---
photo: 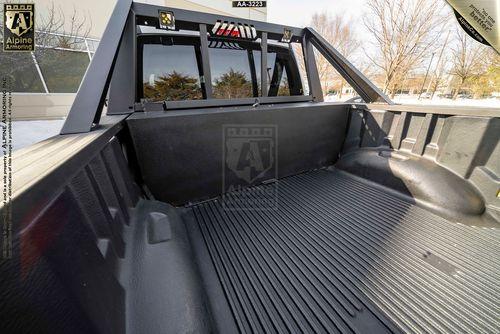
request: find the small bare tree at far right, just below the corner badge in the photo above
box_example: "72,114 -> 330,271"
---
450,27 -> 488,99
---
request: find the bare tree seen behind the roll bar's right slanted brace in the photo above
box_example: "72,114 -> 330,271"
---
310,13 -> 361,96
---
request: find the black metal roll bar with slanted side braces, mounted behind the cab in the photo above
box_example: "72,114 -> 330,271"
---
61,0 -> 392,134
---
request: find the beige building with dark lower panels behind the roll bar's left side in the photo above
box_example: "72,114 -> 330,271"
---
0,0 -> 267,120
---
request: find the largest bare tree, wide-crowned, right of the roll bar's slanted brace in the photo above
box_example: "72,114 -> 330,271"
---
364,0 -> 446,97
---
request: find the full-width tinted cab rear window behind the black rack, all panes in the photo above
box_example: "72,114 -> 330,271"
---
139,36 -> 304,101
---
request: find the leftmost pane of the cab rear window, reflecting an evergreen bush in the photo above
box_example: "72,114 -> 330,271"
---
142,44 -> 203,101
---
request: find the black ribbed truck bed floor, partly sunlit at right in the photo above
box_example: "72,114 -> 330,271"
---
188,170 -> 500,333
